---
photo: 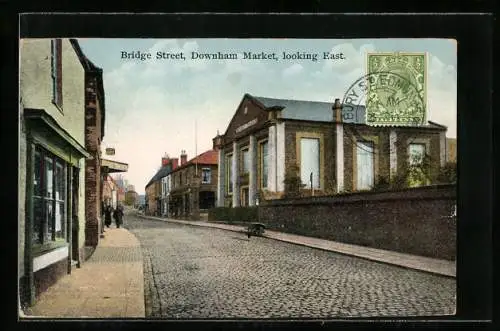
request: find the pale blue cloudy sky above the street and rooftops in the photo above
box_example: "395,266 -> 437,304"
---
78,39 -> 457,194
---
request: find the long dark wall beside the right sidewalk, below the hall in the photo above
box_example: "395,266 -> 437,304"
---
259,185 -> 456,260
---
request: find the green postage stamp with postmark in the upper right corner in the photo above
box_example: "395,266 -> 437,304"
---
366,53 -> 427,126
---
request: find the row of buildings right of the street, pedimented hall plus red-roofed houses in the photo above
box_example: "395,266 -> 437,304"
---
146,94 -> 456,219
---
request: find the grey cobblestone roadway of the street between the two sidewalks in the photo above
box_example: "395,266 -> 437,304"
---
125,215 -> 456,319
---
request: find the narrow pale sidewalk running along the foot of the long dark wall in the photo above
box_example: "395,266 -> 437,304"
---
139,215 -> 456,277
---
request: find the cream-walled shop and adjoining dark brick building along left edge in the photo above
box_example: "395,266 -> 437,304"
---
18,39 -> 128,312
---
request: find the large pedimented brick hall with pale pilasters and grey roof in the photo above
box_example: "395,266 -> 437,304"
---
214,94 -> 446,206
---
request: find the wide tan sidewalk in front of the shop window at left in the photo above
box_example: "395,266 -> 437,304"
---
24,225 -> 145,318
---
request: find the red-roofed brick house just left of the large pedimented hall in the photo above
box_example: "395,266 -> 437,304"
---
167,150 -> 218,220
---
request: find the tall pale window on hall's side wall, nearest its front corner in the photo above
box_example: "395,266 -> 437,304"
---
300,138 -> 320,189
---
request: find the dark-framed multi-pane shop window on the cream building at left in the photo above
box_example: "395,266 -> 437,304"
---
32,147 -> 66,244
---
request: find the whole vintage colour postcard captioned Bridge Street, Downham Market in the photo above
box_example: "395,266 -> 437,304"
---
18,38 -> 457,320
